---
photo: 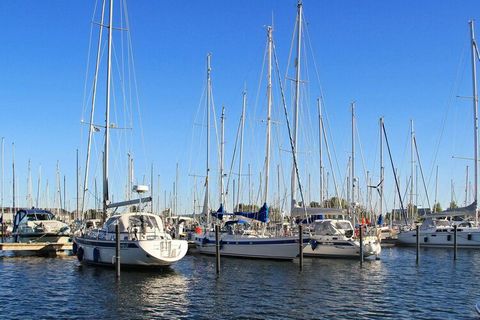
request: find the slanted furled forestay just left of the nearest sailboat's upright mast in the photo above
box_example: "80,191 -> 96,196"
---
81,0 -> 105,218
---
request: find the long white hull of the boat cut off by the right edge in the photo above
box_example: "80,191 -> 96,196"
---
398,228 -> 480,248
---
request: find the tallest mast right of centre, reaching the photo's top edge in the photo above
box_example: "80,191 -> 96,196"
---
291,0 -> 303,211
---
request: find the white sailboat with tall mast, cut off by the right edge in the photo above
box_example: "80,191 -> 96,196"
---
398,21 -> 480,248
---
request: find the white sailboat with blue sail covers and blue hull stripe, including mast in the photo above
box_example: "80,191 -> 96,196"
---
195,27 -> 309,260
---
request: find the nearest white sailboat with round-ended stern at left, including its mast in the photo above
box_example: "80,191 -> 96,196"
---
73,0 -> 188,267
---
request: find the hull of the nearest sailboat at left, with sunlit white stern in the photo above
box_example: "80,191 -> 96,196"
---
74,237 -> 188,267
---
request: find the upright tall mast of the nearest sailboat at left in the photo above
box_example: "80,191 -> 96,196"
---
102,0 -> 113,221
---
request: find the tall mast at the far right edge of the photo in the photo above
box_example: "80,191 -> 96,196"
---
469,20 -> 478,225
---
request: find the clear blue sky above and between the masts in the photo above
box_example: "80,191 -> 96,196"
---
0,0 -> 480,215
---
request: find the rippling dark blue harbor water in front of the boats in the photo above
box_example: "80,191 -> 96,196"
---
0,248 -> 480,319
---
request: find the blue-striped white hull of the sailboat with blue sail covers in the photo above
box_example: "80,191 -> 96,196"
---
195,235 -> 308,260
